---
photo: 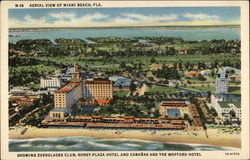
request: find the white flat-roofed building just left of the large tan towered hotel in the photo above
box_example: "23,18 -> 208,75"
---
40,76 -> 62,88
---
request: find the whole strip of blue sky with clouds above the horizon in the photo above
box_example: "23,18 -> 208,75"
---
9,7 -> 240,28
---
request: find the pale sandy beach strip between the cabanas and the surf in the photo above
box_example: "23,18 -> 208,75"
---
9,127 -> 241,148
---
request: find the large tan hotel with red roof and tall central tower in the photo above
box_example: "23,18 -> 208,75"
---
49,63 -> 113,121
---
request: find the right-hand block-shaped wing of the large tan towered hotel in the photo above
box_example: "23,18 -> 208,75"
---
83,79 -> 113,100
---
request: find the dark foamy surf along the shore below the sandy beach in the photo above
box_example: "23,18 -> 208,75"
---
9,137 -> 235,152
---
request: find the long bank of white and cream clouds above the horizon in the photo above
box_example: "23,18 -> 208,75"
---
9,12 -> 239,27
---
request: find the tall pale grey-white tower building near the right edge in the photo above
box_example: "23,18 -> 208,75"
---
215,71 -> 229,93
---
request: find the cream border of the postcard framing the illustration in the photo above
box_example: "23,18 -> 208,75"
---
1,1 -> 249,160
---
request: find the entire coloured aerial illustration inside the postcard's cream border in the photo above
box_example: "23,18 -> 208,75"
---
8,6 -> 241,153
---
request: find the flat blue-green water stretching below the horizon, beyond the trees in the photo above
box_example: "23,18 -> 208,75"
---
9,27 -> 240,42
